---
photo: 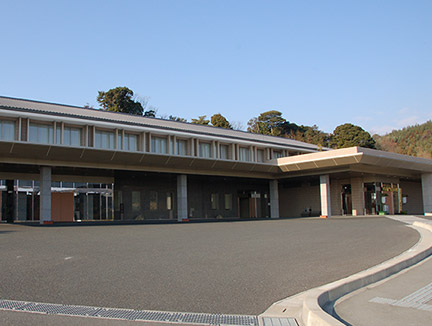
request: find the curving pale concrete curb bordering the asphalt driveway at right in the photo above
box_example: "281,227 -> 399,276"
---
259,216 -> 432,326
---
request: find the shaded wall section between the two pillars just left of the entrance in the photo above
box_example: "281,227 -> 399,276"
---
279,182 -> 321,217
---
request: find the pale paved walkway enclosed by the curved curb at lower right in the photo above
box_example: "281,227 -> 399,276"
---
334,216 -> 432,326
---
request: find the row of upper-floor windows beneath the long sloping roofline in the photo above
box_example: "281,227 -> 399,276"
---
0,119 -> 296,162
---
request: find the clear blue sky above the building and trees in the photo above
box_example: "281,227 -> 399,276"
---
0,0 -> 432,133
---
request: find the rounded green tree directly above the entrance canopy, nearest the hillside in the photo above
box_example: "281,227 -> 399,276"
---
330,123 -> 376,148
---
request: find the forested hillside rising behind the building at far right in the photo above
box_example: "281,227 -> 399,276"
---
373,120 -> 432,158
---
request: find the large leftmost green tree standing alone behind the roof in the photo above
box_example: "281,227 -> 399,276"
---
97,87 -> 144,115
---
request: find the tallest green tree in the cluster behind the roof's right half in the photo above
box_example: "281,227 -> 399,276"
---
247,110 -> 287,136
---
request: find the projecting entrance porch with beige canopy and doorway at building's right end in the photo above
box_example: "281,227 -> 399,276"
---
277,147 -> 432,217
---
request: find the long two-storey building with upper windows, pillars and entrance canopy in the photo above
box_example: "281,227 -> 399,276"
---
0,97 -> 432,223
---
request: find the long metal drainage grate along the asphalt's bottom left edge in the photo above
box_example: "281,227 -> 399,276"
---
0,300 -> 258,326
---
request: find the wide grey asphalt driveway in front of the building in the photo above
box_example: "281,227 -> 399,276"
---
0,217 -> 418,314
